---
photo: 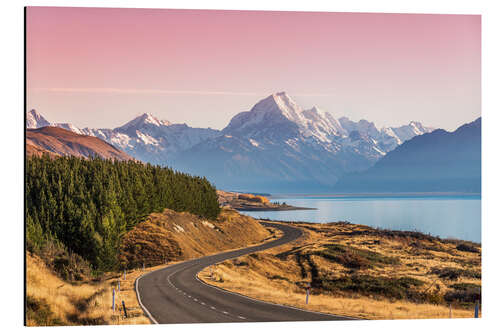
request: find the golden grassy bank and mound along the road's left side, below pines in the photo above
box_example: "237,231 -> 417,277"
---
26,208 -> 275,326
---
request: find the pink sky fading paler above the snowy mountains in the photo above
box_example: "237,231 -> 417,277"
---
27,7 -> 481,130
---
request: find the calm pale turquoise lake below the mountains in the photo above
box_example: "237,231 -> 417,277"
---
242,195 -> 481,242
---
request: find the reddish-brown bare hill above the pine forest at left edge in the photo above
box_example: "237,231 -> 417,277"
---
26,126 -> 132,161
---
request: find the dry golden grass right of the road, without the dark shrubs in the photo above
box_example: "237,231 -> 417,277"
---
200,220 -> 481,319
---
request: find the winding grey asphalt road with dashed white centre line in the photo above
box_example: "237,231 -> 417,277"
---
135,222 -> 353,324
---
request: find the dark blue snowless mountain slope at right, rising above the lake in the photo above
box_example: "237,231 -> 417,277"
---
334,118 -> 481,193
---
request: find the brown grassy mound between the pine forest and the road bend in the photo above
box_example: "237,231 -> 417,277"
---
120,208 -> 270,268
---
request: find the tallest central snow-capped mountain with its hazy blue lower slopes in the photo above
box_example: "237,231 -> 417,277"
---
167,92 -> 432,192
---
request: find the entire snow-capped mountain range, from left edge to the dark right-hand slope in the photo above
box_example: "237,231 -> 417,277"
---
27,92 -> 433,191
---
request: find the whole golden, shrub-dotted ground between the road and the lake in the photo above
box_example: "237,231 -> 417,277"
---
200,223 -> 481,319
